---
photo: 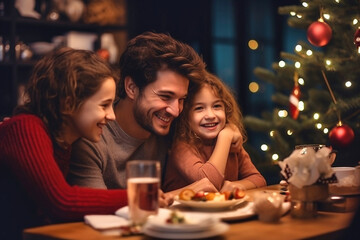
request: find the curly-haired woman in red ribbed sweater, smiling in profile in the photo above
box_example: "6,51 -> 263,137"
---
0,48 -> 169,239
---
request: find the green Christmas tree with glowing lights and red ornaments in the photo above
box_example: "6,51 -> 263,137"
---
244,0 -> 360,178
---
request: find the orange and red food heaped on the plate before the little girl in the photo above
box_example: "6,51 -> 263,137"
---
179,188 -> 245,202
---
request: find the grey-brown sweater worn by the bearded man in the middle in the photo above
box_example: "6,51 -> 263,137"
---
67,121 -> 167,189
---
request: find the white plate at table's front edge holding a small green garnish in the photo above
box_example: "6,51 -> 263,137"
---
145,213 -> 219,232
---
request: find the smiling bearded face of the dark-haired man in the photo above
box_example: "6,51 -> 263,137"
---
134,70 -> 189,135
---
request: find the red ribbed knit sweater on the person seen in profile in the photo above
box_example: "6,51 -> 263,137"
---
0,114 -> 127,224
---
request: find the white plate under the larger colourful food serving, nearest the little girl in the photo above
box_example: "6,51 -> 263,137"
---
176,195 -> 248,210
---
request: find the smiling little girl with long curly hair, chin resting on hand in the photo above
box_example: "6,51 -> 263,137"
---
163,73 -> 266,192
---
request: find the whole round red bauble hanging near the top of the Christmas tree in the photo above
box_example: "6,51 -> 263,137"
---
307,20 -> 332,47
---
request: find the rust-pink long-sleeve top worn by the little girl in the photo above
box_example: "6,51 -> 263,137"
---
162,142 -> 266,192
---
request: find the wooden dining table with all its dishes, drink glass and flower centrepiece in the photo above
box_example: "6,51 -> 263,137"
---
24,150 -> 360,240
